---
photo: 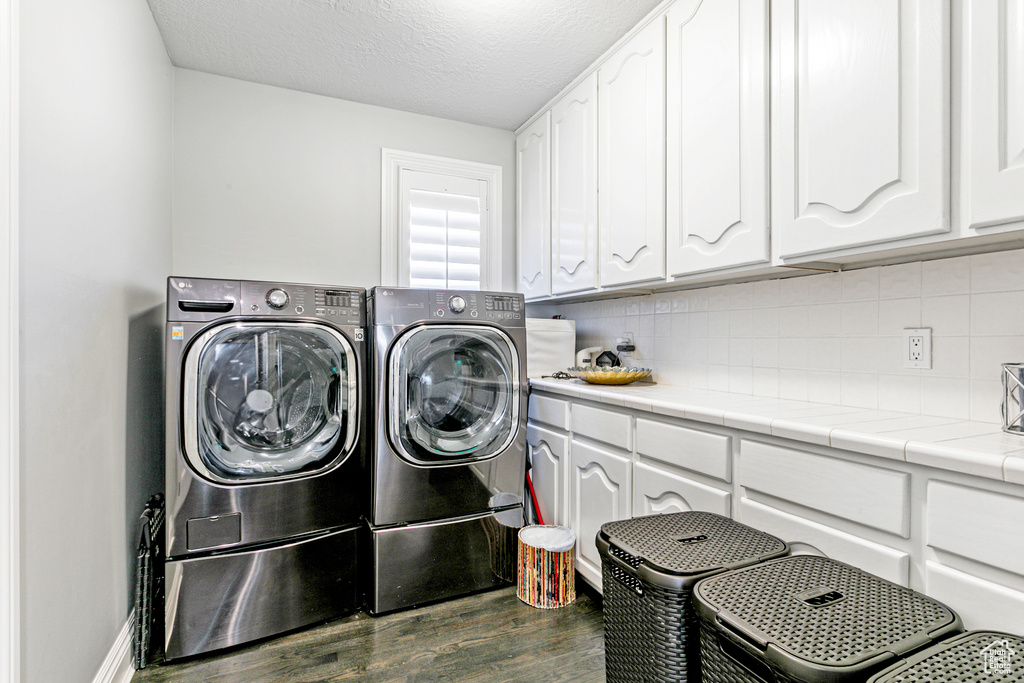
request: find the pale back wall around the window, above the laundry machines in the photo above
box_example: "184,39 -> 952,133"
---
173,69 -> 515,289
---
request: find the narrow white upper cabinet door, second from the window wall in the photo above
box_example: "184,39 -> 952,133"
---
551,73 -> 597,294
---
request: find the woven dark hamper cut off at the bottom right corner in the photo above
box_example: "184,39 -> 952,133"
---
868,631 -> 1024,683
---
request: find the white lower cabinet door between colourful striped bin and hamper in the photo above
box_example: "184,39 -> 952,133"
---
568,439 -> 632,590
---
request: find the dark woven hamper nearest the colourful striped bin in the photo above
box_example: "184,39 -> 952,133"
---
597,512 -> 788,683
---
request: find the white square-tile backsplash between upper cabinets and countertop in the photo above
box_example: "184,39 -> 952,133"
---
545,250 -> 1024,423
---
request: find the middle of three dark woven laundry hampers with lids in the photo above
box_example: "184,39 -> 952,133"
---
693,556 -> 963,683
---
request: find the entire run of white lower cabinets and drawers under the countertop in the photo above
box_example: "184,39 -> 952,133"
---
526,392 -> 1024,622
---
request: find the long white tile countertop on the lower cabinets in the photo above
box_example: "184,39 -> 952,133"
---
529,379 -> 1024,484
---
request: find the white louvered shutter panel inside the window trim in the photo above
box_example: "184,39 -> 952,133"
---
398,169 -> 486,290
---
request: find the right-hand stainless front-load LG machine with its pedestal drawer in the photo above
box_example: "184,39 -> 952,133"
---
367,287 -> 526,613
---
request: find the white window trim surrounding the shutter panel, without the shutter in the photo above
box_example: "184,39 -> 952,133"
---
381,148 -> 502,290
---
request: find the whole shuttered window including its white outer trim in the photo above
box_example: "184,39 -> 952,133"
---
381,150 -> 502,290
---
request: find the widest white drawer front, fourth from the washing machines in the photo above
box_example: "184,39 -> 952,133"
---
739,439 -> 910,539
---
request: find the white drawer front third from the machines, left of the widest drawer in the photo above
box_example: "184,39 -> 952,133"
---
637,418 -> 732,481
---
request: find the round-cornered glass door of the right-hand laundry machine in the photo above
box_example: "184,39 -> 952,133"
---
386,326 -> 520,466
